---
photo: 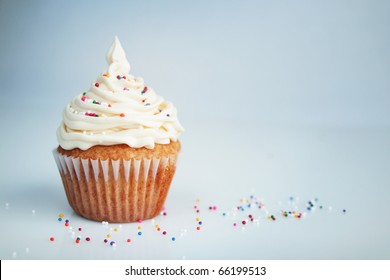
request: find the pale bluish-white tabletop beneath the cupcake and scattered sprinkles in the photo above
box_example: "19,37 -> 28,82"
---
0,123 -> 390,259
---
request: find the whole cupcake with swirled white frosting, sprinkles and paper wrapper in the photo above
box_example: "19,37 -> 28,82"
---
53,37 -> 183,223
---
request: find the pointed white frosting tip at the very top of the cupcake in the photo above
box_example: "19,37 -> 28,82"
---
106,36 -> 130,75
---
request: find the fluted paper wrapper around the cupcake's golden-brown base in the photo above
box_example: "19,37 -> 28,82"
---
53,150 -> 177,223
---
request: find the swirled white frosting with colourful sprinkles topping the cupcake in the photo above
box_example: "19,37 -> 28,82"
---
57,37 -> 183,150
